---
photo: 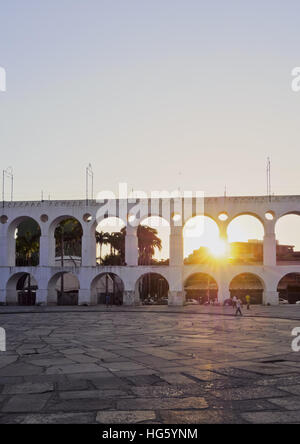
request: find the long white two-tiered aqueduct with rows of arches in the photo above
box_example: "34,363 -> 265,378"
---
0,196 -> 300,305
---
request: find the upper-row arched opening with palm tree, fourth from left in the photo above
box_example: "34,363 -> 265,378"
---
137,216 -> 170,265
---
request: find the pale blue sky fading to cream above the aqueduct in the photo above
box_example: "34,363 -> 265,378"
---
0,0 -> 300,199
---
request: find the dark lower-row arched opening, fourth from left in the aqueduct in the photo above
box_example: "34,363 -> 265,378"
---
135,273 -> 169,305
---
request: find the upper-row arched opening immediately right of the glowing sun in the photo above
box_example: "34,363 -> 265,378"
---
227,214 -> 264,264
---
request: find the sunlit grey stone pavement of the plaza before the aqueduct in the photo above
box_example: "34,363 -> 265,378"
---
0,306 -> 300,424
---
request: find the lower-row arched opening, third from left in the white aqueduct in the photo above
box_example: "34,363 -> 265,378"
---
91,273 -> 124,305
